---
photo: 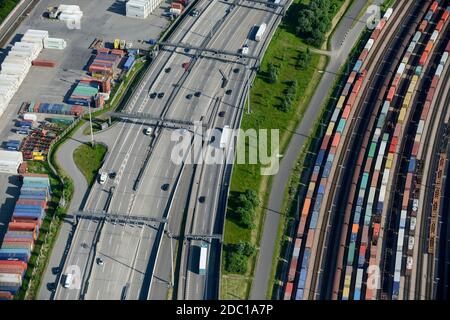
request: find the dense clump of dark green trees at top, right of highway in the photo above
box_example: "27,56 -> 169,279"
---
295,0 -> 344,48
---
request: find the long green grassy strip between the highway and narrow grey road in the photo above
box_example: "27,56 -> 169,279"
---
221,0 -> 327,299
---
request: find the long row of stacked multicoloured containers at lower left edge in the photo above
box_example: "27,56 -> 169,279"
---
0,174 -> 51,300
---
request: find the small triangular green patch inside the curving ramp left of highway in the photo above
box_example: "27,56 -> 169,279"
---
73,143 -> 107,186
